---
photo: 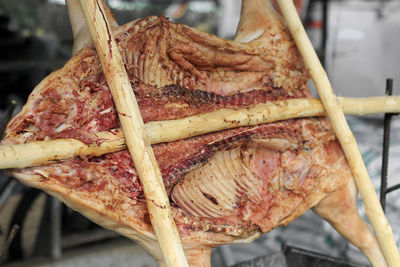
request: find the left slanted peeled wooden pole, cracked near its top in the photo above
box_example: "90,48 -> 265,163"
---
80,0 -> 188,267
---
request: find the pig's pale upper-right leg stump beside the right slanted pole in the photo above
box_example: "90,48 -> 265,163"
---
234,0 -> 284,45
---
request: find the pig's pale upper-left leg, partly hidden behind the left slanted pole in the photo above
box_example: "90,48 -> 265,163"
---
65,0 -> 118,55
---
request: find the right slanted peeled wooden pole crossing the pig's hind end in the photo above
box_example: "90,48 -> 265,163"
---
278,0 -> 400,266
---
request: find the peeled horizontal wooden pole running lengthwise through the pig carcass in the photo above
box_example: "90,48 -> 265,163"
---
0,96 -> 400,169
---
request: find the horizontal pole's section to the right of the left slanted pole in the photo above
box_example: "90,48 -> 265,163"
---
145,96 -> 400,144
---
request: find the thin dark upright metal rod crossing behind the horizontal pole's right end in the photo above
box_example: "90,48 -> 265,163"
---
380,79 -> 393,211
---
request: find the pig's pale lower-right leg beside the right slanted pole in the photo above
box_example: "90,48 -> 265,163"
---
313,179 -> 387,266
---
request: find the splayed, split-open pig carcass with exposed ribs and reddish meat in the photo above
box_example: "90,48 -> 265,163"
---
2,0 -> 385,266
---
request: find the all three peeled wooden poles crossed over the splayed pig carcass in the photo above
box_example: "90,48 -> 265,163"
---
0,0 -> 400,266
